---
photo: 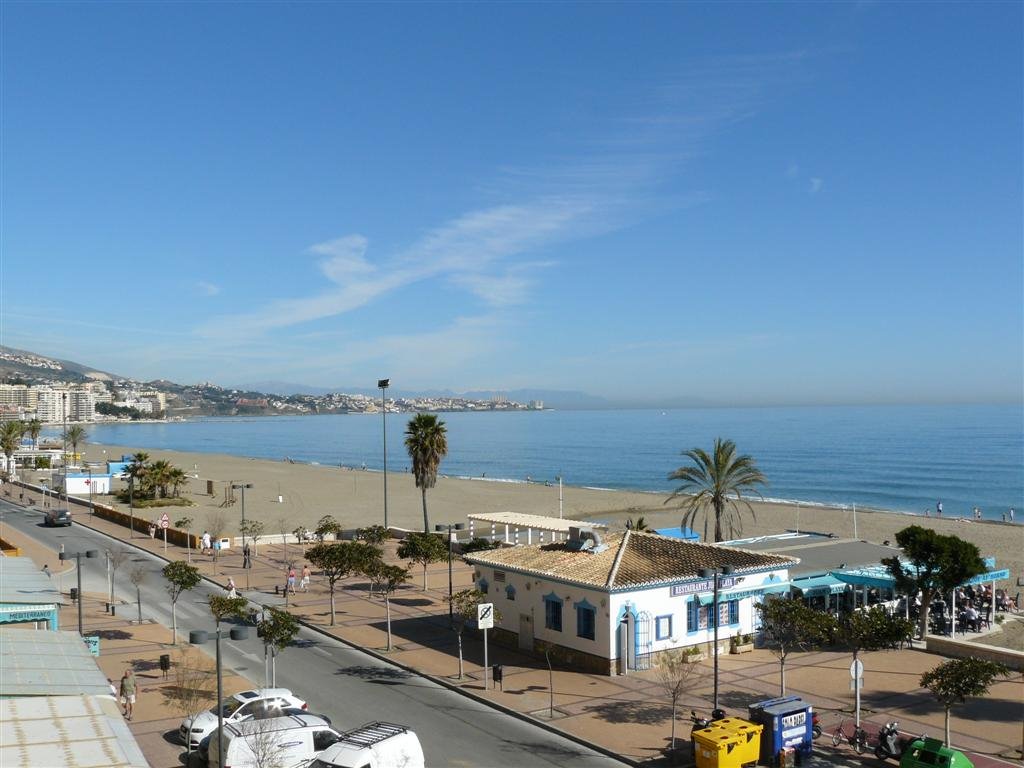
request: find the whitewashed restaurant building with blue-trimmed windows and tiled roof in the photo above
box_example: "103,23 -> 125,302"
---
464,527 -> 799,675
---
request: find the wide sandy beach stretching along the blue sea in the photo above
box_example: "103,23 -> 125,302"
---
75,444 -> 1024,591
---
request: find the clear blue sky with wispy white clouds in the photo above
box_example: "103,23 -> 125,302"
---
0,2 -> 1024,404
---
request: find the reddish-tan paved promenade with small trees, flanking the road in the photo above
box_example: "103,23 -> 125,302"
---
4,489 -> 1024,768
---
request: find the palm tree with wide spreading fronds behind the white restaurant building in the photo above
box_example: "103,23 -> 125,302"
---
665,437 -> 768,542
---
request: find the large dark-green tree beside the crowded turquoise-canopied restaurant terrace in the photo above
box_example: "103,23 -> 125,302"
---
882,525 -> 985,637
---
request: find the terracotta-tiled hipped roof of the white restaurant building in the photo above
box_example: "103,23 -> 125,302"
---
465,530 -> 798,591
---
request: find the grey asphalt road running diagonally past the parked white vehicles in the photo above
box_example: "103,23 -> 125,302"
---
0,501 -> 624,767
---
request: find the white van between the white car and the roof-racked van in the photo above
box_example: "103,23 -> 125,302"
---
207,715 -> 341,768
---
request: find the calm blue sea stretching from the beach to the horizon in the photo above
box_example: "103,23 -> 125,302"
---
81,406 -> 1024,522
